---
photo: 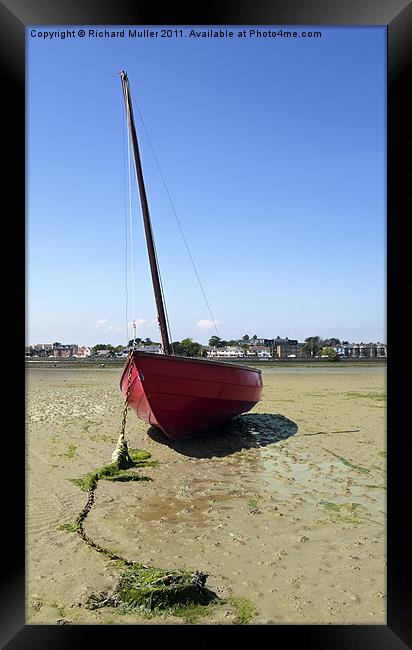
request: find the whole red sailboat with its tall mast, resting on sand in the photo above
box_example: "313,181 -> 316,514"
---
120,71 -> 262,439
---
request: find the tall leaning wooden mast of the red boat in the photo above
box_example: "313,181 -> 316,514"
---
120,70 -> 171,354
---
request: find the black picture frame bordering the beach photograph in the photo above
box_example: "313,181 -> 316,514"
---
4,0 -> 412,650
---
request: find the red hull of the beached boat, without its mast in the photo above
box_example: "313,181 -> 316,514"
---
120,351 -> 262,440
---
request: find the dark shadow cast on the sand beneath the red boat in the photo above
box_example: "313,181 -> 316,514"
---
147,413 -> 298,458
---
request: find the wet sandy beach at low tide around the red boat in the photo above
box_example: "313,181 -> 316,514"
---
26,363 -> 386,625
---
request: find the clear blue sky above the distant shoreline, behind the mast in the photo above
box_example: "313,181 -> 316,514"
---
26,25 -> 386,346
